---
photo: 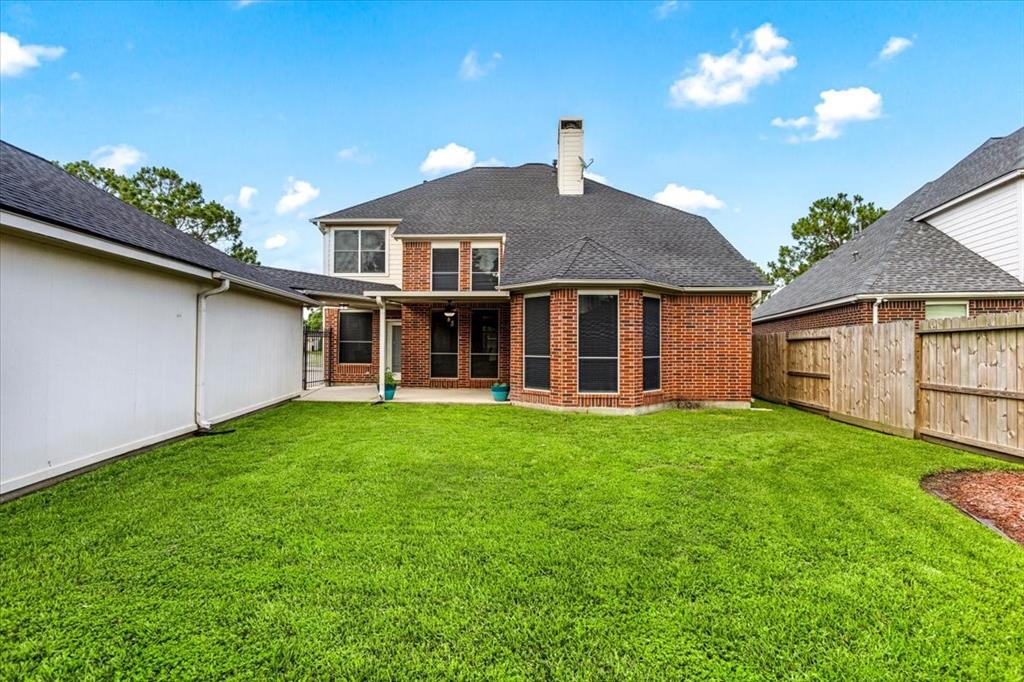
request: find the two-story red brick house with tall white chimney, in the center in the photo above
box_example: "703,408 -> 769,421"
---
309,119 -> 766,412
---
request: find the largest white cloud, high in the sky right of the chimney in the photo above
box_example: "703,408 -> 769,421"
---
669,24 -> 797,106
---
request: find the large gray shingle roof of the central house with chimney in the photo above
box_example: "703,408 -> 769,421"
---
317,164 -> 765,289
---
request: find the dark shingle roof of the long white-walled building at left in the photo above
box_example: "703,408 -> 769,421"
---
0,141 -> 376,296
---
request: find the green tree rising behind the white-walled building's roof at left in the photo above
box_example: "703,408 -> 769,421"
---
63,161 -> 259,265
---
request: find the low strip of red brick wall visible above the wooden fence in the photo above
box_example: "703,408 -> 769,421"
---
754,299 -> 1024,334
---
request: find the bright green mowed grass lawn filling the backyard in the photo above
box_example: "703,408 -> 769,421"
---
0,402 -> 1024,681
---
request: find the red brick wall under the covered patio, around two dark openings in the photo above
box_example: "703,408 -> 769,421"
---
401,303 -> 512,388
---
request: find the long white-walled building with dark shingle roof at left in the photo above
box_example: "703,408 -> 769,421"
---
0,142 -> 361,498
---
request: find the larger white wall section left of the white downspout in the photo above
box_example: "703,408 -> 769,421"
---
0,235 -> 202,492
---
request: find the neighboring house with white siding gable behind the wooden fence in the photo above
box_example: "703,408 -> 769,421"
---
754,128 -> 1024,333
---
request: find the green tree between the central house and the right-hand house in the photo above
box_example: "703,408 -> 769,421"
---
767,193 -> 886,287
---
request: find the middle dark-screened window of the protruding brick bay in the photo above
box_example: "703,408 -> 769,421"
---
578,294 -> 618,393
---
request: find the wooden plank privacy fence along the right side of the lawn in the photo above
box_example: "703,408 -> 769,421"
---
753,312 -> 1024,458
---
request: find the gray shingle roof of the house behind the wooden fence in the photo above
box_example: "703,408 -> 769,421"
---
754,128 -> 1024,322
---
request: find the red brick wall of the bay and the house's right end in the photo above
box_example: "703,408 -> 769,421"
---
510,289 -> 751,408
